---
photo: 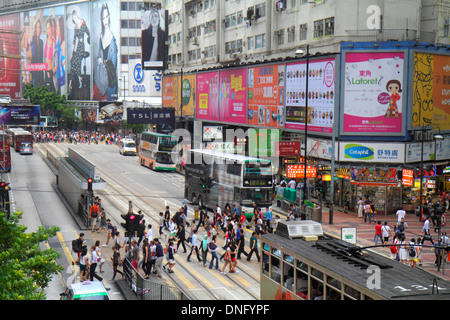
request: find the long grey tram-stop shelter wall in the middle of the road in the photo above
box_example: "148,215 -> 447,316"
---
54,148 -> 106,229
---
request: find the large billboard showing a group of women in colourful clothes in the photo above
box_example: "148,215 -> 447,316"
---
20,6 -> 67,94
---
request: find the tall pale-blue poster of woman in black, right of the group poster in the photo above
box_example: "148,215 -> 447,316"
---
65,2 -> 92,100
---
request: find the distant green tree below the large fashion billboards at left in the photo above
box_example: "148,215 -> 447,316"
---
24,84 -> 79,127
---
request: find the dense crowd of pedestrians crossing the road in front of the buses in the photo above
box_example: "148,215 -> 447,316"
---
73,197 -> 279,281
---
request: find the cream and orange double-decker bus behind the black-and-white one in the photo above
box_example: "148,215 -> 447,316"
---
139,132 -> 178,171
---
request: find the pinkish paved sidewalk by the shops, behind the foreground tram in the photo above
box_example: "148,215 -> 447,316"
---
272,201 -> 450,280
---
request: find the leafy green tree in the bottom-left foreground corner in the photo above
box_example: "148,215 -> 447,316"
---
0,211 -> 63,300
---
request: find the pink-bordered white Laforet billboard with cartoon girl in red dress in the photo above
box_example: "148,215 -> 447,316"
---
341,52 -> 406,135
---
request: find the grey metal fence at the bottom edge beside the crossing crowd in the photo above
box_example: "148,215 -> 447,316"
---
123,255 -> 190,300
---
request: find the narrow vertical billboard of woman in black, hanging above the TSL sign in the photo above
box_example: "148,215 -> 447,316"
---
141,9 -> 169,69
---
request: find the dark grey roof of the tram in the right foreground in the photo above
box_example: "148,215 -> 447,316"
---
261,222 -> 450,300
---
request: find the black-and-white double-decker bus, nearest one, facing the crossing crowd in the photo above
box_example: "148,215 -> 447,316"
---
184,149 -> 273,213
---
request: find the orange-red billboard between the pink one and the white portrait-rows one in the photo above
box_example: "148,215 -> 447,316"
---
247,65 -> 285,128
